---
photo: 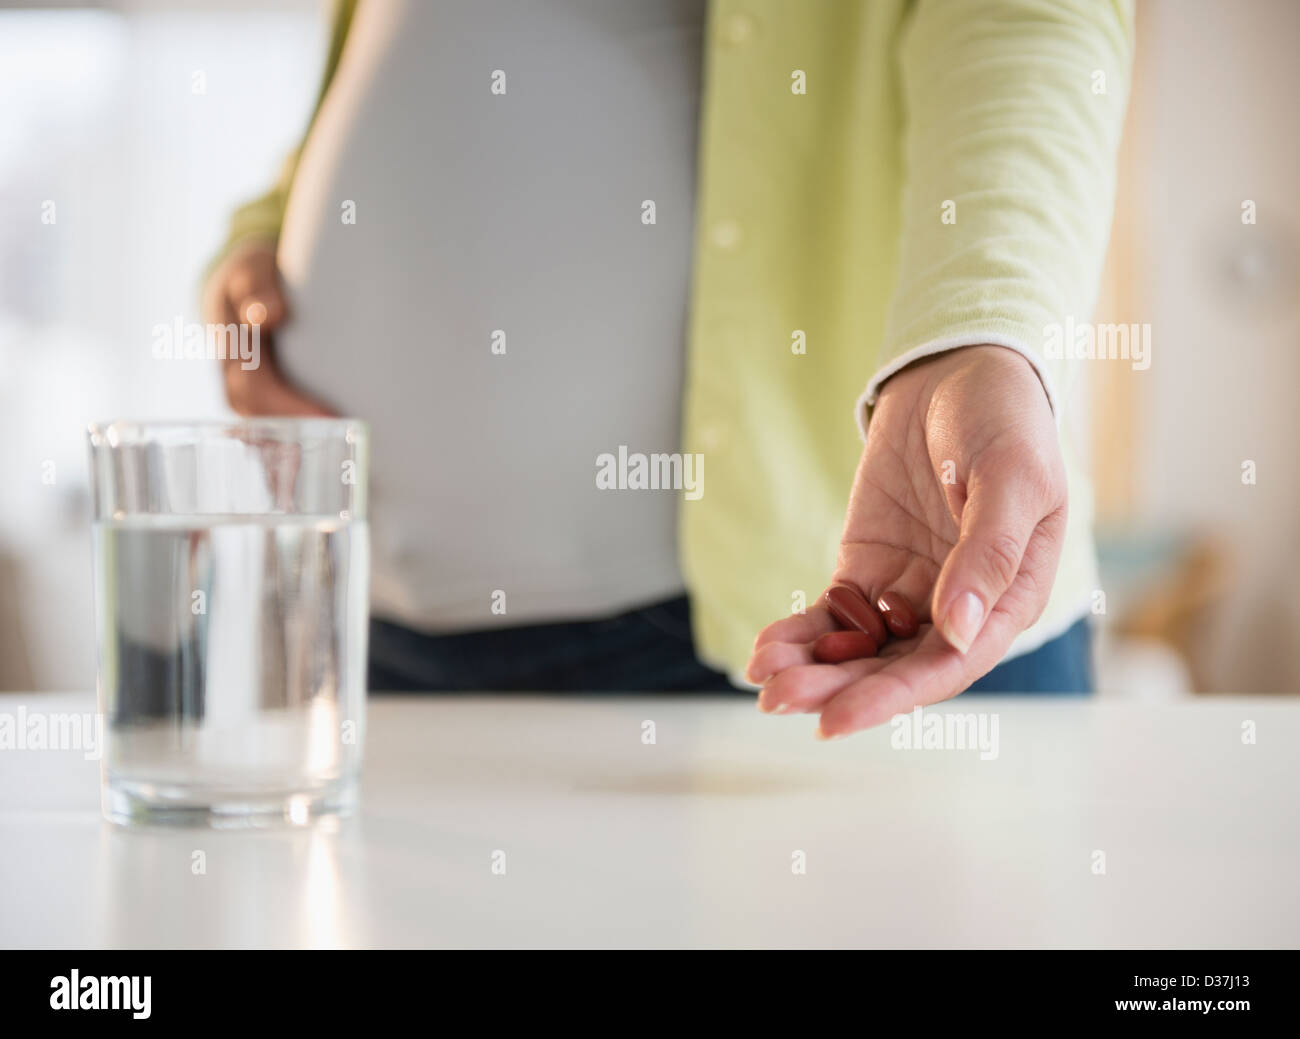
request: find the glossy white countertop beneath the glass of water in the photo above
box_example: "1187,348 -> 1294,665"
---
0,693 -> 1300,947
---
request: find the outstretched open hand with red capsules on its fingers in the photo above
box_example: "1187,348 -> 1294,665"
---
748,346 -> 1066,739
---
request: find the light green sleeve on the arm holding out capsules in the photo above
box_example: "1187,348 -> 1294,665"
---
863,0 -> 1132,421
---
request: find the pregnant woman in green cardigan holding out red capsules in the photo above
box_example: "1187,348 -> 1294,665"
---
205,0 -> 1132,737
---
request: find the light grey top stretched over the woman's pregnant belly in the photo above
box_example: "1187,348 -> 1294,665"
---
277,0 -> 705,631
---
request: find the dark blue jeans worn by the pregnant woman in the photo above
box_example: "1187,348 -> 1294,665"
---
369,596 -> 1092,696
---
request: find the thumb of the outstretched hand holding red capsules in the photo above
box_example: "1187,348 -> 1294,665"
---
933,466 -> 1050,653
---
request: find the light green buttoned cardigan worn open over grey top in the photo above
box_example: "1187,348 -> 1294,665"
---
213,0 -> 1134,675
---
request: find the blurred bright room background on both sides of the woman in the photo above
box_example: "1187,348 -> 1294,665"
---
0,0 -> 1300,700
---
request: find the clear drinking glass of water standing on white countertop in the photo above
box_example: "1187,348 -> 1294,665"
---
90,419 -> 369,826
